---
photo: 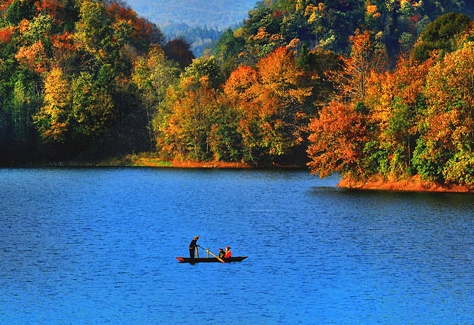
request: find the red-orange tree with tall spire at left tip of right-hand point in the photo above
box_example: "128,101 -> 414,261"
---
307,30 -> 387,177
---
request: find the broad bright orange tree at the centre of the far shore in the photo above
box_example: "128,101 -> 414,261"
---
224,47 -> 312,161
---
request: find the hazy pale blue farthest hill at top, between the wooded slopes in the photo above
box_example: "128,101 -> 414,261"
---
126,0 -> 257,29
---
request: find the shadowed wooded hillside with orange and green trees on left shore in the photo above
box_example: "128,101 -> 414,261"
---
0,0 -> 193,163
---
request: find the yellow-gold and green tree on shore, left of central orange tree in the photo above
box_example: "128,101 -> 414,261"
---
154,53 -> 240,161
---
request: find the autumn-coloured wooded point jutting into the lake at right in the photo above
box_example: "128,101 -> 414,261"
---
308,13 -> 474,190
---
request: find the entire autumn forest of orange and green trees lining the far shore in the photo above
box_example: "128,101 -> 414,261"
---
0,0 -> 474,189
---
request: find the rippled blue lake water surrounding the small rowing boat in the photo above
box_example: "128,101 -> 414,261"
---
0,168 -> 474,324
